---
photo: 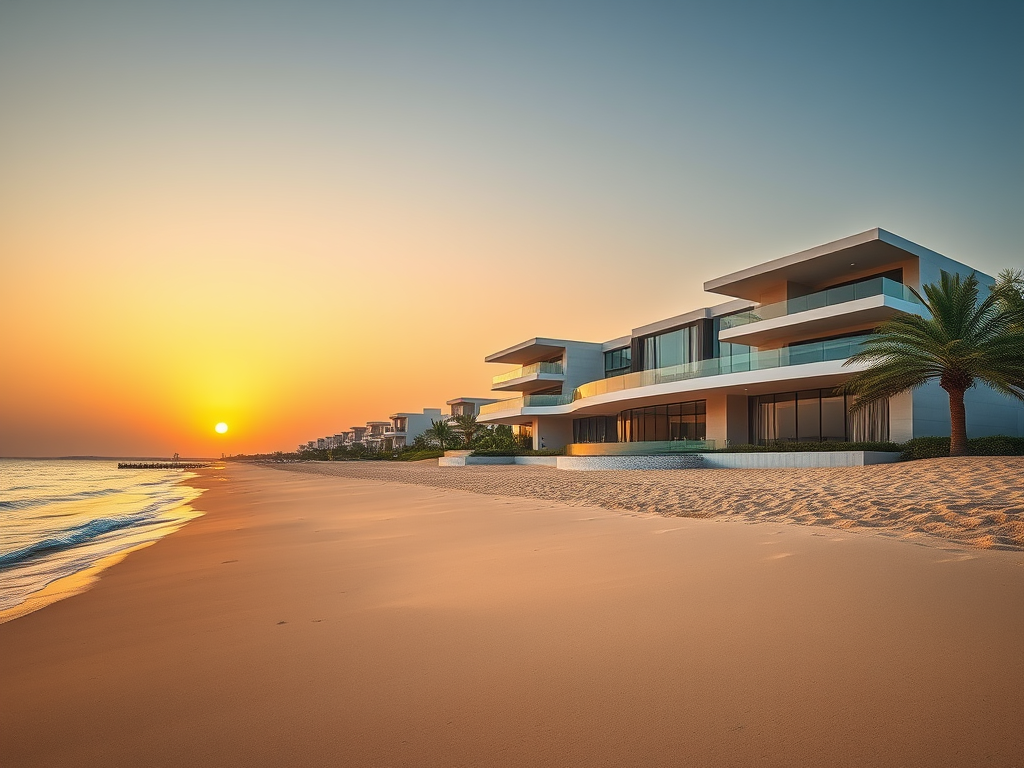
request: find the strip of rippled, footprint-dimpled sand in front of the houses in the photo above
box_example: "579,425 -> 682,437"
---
270,457 -> 1024,550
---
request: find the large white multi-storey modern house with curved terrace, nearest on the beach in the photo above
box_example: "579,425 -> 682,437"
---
478,229 -> 1024,456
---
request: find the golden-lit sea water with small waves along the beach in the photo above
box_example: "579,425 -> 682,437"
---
0,459 -> 200,621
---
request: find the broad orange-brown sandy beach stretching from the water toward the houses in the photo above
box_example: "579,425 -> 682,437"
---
0,462 -> 1024,768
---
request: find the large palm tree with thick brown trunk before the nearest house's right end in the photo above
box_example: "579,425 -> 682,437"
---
842,271 -> 1024,456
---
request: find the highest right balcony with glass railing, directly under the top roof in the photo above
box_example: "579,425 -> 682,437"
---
719,278 -> 922,346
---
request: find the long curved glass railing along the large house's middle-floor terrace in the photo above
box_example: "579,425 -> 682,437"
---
573,335 -> 868,410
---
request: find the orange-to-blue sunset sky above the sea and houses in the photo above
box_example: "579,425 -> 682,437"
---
0,0 -> 1024,456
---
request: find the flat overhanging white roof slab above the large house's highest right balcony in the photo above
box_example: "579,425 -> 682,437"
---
705,227 -> 941,301
